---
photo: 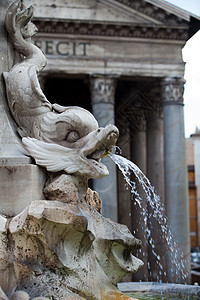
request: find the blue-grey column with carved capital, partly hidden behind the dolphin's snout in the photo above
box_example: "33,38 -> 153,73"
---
90,75 -> 118,221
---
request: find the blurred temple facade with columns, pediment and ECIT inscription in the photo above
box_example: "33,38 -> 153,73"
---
32,0 -> 200,282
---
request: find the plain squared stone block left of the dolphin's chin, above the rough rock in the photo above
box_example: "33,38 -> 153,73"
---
0,164 -> 46,216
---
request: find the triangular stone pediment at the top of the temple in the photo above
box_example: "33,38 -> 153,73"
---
32,0 -> 188,26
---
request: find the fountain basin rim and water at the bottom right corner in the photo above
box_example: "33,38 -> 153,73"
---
118,282 -> 200,299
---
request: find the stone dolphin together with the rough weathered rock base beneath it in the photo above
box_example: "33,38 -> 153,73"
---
0,1 -> 143,300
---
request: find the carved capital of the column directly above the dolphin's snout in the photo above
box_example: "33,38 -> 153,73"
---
90,74 -> 119,104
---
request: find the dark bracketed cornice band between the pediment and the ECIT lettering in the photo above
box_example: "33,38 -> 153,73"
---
34,19 -> 188,41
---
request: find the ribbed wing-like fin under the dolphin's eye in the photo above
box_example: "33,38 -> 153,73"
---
22,137 -> 81,174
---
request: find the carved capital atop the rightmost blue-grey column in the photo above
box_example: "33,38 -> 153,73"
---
161,77 -> 185,105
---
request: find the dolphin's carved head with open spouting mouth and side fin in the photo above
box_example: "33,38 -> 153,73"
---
23,106 -> 119,178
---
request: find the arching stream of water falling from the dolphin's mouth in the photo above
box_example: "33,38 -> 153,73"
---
109,153 -> 189,282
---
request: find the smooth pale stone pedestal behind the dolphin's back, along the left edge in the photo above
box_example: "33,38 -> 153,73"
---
0,0 -> 45,216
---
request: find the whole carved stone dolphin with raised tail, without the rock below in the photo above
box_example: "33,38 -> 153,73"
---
3,1 -> 118,178
